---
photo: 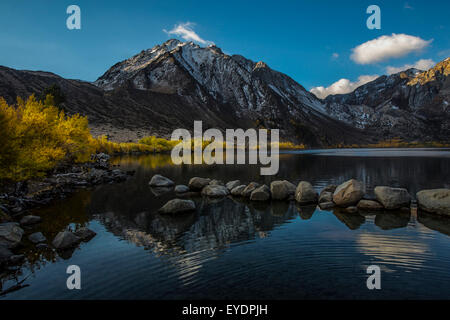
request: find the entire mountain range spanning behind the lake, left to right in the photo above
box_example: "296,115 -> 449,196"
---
0,39 -> 450,147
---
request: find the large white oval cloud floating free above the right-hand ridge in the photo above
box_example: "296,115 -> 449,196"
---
351,33 -> 433,64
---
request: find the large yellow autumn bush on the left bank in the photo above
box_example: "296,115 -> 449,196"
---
0,95 -> 95,181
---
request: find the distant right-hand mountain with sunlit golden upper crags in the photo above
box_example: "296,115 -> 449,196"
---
324,58 -> 450,141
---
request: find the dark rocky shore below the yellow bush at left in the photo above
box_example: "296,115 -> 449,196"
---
0,153 -> 134,271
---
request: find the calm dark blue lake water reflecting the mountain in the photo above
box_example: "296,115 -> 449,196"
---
0,149 -> 450,299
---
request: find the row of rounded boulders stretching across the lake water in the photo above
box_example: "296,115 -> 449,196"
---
149,174 -> 450,215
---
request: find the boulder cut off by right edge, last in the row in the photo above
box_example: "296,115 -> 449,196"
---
416,189 -> 450,215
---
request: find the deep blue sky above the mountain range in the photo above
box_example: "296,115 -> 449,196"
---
0,0 -> 450,95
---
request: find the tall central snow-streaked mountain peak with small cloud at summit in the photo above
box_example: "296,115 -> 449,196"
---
95,39 -> 369,146
